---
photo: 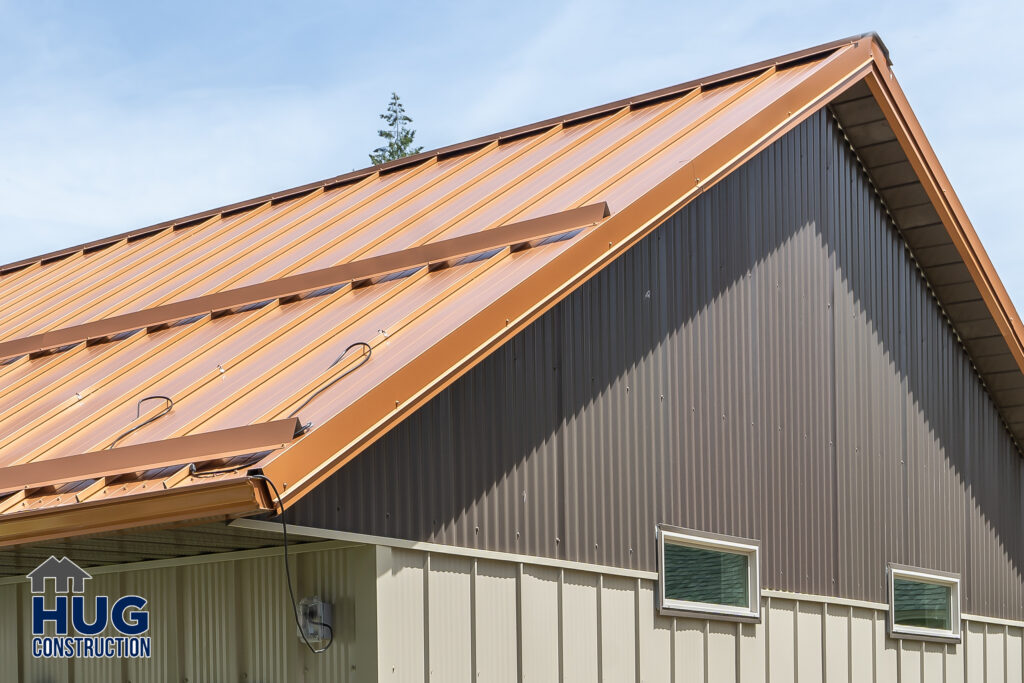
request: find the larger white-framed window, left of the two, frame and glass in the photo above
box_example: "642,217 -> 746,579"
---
657,524 -> 761,621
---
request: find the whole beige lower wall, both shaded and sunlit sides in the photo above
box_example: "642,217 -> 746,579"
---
0,543 -> 1024,683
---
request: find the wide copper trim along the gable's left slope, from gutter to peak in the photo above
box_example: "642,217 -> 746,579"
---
262,41 -> 882,507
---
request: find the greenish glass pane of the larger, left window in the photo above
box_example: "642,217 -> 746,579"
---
665,543 -> 750,607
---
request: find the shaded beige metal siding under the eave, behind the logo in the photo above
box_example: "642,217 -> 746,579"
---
0,547 -> 376,683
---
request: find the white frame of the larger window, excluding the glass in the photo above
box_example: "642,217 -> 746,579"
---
657,524 -> 761,622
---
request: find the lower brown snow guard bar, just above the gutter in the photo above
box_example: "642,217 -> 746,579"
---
0,418 -> 299,492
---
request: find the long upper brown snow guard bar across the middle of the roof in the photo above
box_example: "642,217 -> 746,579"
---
0,202 -> 609,358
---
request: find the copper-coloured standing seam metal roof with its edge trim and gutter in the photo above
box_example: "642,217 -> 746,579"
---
0,36 -> 1024,545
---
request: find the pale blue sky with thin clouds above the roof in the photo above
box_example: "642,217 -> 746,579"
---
0,0 -> 1024,309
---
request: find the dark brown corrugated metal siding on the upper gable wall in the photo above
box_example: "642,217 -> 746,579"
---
295,112 -> 1024,618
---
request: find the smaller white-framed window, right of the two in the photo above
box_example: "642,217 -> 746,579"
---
888,564 -> 961,642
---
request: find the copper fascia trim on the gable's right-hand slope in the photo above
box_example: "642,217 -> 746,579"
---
866,59 -> 1024,372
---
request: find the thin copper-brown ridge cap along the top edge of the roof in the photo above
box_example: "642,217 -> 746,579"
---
0,33 -> 889,274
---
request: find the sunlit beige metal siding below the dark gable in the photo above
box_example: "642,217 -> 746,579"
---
377,547 -> 1024,683
